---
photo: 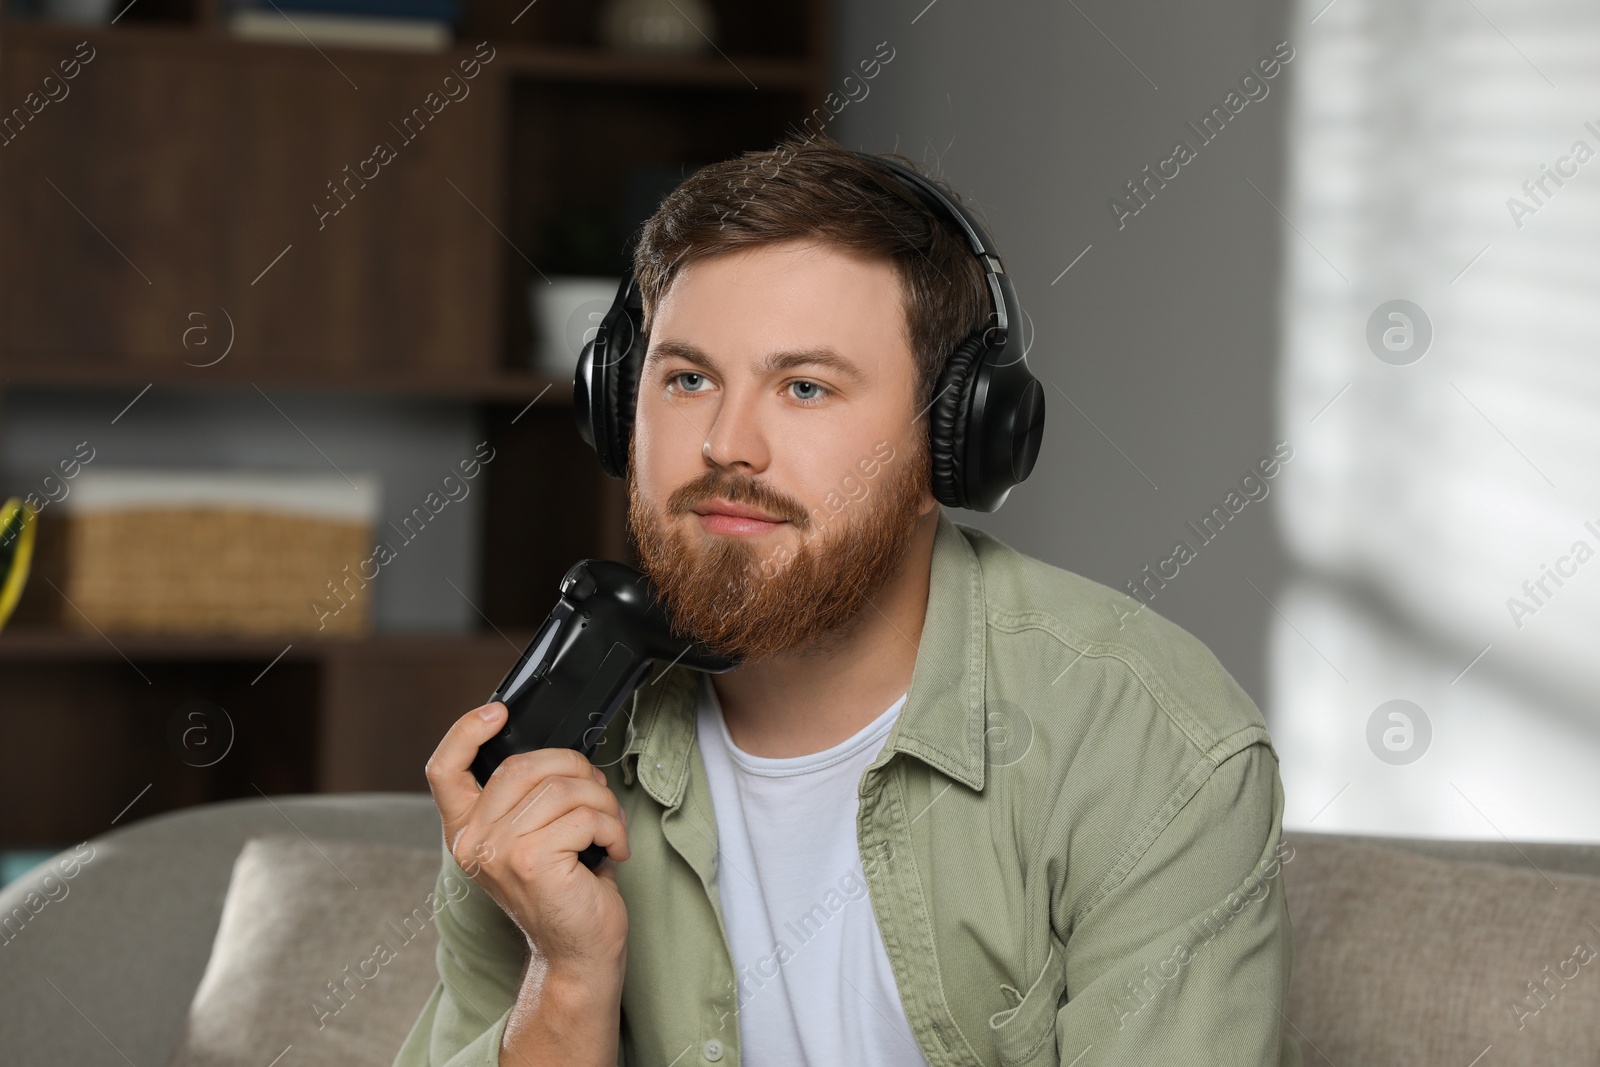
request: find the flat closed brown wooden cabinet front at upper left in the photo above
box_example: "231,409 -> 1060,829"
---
0,20 -> 506,374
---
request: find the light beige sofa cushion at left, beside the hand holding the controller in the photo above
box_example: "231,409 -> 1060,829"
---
170,835 -> 466,1067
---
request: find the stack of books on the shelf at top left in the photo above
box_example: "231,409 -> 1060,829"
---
227,0 -> 461,51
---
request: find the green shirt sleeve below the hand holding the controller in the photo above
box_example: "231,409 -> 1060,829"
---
394,838 -> 528,1067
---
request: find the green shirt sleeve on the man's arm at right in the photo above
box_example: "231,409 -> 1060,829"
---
1054,741 -> 1301,1067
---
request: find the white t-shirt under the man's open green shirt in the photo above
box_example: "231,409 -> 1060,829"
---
696,675 -> 928,1067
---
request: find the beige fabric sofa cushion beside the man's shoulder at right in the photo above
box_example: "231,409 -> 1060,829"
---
1283,835 -> 1600,1067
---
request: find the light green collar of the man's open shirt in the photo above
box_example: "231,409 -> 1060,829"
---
621,509 -> 987,808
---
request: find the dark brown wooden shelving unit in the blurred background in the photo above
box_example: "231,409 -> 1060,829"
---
0,0 -> 829,846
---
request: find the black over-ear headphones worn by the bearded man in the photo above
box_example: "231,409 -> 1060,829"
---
573,152 -> 1045,512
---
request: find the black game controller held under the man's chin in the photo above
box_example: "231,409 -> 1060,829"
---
472,560 -> 739,870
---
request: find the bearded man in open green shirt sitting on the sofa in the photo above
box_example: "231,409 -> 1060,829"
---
395,139 -> 1299,1067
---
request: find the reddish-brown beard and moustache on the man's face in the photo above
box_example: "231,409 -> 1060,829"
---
627,430 -> 930,662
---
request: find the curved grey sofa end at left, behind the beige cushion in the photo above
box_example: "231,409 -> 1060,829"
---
0,793 -> 442,1067
